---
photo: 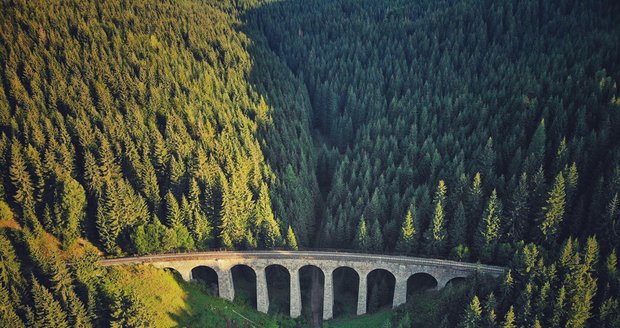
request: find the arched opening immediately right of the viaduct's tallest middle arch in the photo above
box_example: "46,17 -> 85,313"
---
332,267 -> 360,318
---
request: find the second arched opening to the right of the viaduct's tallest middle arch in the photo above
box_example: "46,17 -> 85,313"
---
366,269 -> 396,313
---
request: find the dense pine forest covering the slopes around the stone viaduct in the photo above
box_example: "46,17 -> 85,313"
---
0,0 -> 620,328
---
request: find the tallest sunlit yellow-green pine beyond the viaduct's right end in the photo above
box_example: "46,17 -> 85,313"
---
540,172 -> 566,243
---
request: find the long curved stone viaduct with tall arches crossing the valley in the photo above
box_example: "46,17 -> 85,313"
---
100,250 -> 504,320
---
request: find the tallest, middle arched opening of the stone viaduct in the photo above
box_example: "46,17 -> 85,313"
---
299,265 -> 325,323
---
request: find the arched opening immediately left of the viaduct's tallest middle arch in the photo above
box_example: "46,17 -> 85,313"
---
265,264 -> 291,315
